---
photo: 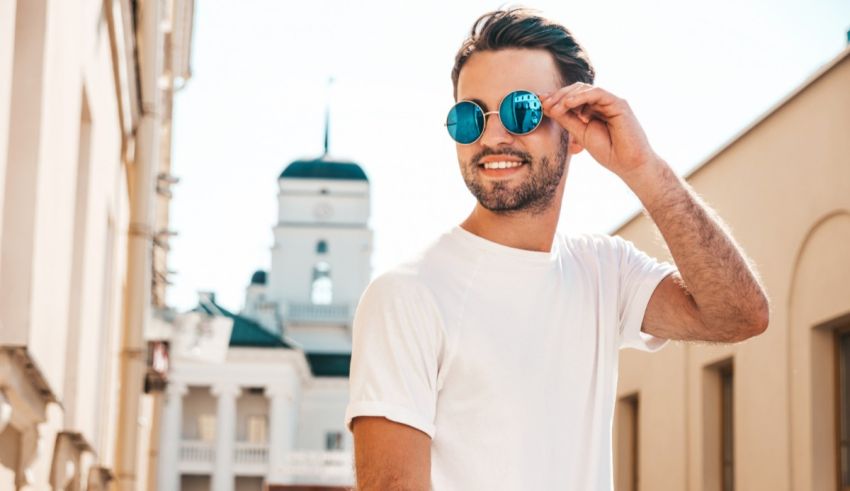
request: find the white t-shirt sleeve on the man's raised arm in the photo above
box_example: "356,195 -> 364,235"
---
614,236 -> 676,351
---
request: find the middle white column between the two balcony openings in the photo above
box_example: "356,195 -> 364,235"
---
212,384 -> 239,491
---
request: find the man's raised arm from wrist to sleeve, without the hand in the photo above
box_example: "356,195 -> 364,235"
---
623,160 -> 769,342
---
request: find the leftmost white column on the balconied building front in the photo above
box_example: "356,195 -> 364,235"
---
157,381 -> 188,491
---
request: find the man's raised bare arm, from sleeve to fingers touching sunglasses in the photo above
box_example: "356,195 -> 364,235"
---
543,82 -> 769,342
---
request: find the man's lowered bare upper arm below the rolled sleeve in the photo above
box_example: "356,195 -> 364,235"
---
351,416 -> 431,491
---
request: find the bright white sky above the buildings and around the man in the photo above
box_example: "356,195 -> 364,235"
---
168,0 -> 850,310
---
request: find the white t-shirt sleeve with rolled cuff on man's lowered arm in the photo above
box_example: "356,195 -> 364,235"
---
345,273 -> 445,438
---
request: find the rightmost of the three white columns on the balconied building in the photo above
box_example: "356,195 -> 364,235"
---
266,374 -> 298,484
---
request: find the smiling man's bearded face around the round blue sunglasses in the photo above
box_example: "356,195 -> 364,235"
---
457,49 -> 581,214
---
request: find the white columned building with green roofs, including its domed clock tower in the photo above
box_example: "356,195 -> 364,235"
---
159,157 -> 372,491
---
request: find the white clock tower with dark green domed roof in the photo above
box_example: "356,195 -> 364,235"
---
263,155 -> 372,353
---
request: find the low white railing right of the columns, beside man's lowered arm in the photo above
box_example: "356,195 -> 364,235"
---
283,450 -> 354,486
